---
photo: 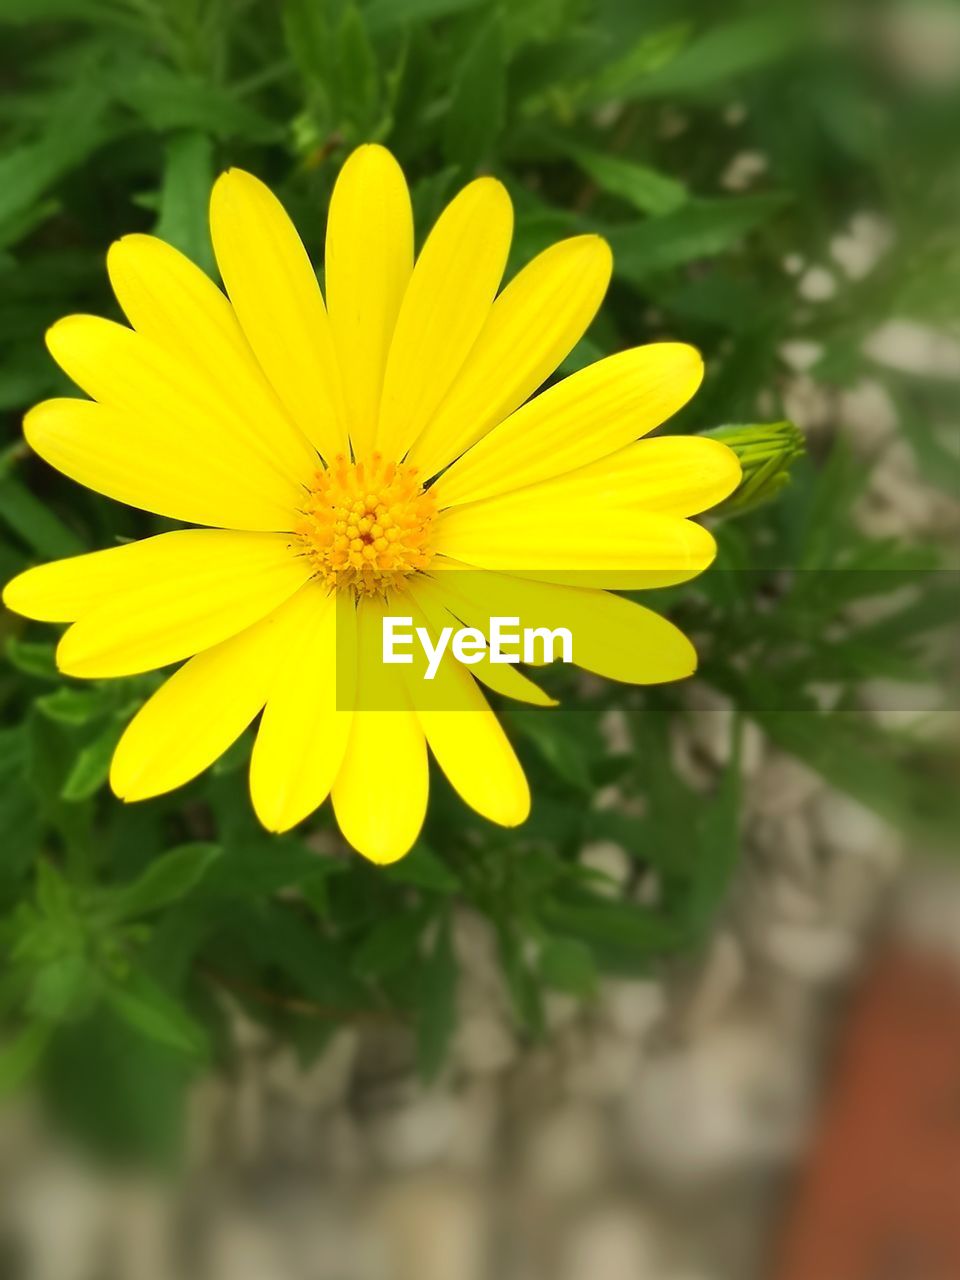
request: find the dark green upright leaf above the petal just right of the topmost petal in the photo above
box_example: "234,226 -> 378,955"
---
444,14 -> 507,170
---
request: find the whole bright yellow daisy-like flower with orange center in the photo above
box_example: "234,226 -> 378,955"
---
4,146 -> 740,863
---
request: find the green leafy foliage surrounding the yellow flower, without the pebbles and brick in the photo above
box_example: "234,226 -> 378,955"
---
0,0 -> 960,1161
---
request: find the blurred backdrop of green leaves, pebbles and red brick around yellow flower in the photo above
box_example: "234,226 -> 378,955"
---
0,0 -> 960,1280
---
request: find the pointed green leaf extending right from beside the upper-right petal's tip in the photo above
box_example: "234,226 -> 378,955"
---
604,193 -> 786,284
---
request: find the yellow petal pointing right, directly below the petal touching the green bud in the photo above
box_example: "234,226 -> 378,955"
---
434,485 -> 717,589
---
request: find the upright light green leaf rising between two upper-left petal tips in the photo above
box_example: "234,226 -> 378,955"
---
154,131 -> 215,275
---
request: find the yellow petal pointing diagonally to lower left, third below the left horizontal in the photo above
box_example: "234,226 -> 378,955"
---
110,588 -> 310,800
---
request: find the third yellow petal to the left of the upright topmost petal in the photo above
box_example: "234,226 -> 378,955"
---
46,315 -> 315,519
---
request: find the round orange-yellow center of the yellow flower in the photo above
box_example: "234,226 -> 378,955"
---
293,453 -> 436,594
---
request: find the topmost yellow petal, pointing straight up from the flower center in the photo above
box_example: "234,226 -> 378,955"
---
324,146 -> 413,457
